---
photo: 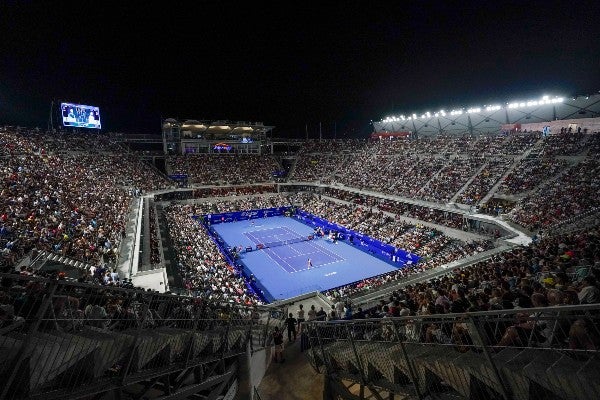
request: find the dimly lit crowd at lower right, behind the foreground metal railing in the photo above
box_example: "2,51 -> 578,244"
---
330,226 -> 600,350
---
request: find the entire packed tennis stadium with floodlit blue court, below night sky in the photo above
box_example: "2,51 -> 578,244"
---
0,0 -> 600,400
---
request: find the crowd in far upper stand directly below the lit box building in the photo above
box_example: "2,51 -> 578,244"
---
167,154 -> 281,185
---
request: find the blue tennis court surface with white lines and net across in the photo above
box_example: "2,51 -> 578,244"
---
213,217 -> 402,300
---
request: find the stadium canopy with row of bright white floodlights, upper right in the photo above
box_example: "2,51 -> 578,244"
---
373,94 -> 600,136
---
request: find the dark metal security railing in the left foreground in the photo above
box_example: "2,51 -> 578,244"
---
0,274 -> 281,400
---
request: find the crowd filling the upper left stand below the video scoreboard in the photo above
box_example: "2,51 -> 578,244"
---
0,129 -> 169,267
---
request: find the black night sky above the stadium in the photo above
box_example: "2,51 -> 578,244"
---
0,0 -> 600,136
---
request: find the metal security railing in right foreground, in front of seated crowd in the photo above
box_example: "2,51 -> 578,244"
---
304,304 -> 600,400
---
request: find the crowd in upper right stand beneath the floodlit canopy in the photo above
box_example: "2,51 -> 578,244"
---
284,132 -> 600,229
